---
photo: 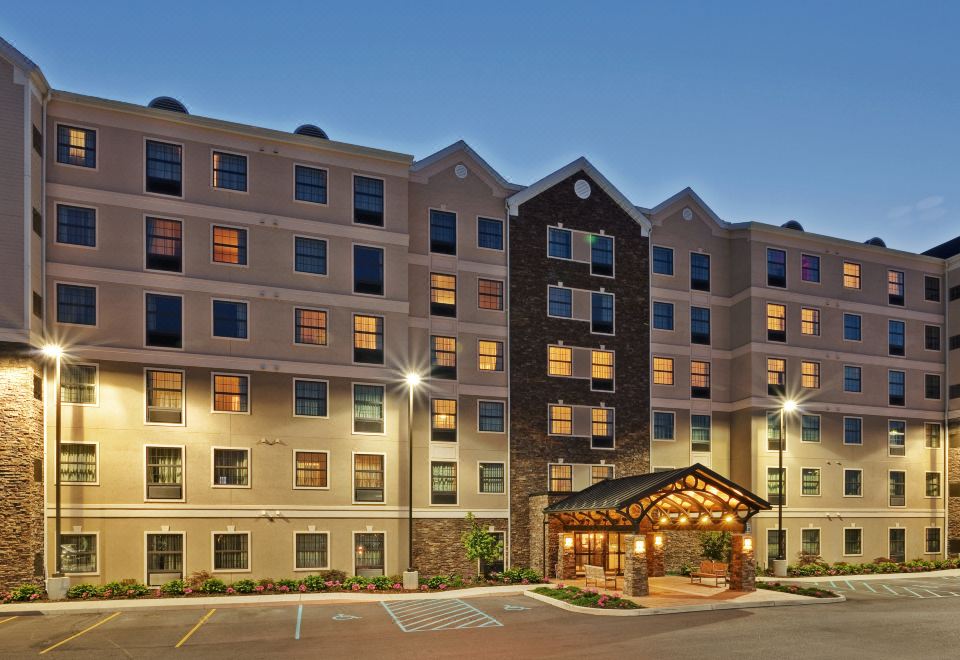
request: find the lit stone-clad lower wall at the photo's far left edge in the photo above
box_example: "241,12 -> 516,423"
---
0,344 -> 44,591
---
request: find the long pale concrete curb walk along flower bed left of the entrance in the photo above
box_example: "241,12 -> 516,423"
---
0,584 -> 543,616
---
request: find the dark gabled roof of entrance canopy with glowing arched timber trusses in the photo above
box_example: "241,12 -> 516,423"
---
543,463 -> 770,533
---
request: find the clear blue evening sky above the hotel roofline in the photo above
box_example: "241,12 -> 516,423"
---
0,0 -> 960,251
